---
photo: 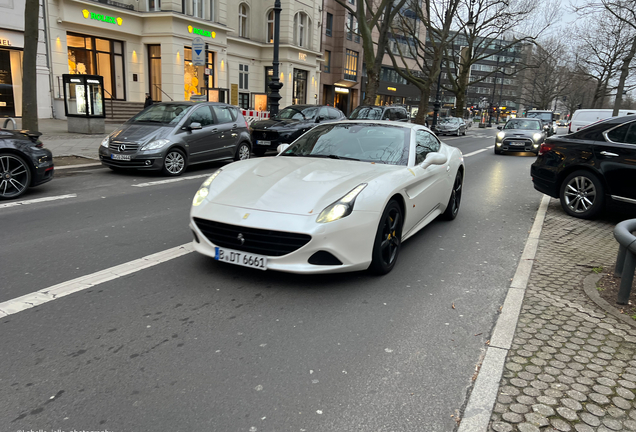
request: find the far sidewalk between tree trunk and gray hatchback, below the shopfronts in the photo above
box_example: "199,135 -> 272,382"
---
16,119 -> 120,160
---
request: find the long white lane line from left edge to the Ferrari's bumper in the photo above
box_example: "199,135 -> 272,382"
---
0,243 -> 194,318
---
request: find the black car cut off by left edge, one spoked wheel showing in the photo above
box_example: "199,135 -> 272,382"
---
0,129 -> 53,199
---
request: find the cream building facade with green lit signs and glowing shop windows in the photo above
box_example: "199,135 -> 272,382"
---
46,0 -> 322,117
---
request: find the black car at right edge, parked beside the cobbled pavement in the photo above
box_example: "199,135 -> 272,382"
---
531,115 -> 636,219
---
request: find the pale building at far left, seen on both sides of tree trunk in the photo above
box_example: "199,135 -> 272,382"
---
0,0 -> 51,118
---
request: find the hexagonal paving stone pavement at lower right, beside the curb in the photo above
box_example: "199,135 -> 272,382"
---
488,199 -> 636,432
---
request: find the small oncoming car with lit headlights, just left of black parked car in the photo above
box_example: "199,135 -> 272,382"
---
495,118 -> 546,154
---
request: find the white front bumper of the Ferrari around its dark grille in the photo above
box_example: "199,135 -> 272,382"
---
190,202 -> 380,274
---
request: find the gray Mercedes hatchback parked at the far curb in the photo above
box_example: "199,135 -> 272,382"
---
99,102 -> 252,176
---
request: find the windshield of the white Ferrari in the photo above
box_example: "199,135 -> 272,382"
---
282,123 -> 411,165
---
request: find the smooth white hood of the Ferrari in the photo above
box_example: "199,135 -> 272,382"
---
208,156 -> 396,216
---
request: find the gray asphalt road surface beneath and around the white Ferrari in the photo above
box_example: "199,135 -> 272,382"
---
0,128 -> 556,432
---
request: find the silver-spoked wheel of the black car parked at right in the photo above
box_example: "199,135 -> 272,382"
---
559,170 -> 605,219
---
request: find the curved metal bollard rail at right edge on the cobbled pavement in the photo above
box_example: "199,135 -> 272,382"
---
614,219 -> 636,305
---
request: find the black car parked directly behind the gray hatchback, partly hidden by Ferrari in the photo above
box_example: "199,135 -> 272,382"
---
250,105 -> 346,156
